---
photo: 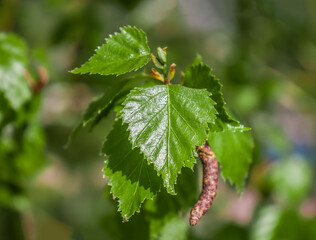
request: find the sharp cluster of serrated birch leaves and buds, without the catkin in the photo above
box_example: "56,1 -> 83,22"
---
72,27 -> 253,221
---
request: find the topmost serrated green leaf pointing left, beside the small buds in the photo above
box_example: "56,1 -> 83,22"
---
72,26 -> 150,75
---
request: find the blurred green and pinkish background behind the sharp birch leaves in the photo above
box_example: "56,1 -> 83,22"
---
0,0 -> 316,240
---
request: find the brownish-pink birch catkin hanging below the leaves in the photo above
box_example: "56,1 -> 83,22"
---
190,142 -> 218,226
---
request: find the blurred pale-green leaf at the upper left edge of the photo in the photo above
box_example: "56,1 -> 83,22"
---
0,33 -> 32,110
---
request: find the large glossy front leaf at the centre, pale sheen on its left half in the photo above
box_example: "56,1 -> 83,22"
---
122,85 -> 216,194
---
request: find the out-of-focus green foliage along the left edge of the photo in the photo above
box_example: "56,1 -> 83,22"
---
0,33 -> 44,209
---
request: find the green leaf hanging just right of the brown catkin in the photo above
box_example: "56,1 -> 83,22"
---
208,131 -> 254,192
